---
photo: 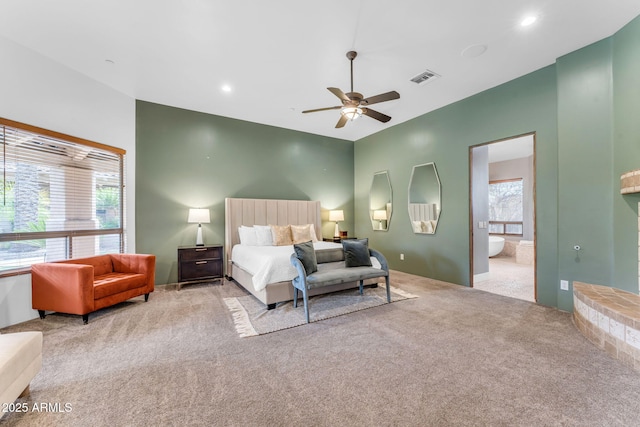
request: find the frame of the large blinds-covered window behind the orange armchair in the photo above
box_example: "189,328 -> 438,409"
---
0,117 -> 126,278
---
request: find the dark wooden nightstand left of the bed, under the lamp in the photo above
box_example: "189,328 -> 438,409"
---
178,245 -> 224,290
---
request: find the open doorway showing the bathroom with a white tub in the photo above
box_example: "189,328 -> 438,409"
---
469,133 -> 537,302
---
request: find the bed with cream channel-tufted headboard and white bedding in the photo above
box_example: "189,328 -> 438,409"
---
224,198 -> 377,309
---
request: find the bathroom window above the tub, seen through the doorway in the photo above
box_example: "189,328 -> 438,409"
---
489,178 -> 523,236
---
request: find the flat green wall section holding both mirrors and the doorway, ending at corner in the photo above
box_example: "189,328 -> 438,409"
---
355,66 -> 558,306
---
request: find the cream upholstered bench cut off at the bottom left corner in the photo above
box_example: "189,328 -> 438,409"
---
0,332 -> 42,417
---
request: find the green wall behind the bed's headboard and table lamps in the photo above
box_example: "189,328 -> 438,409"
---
135,101 -> 354,284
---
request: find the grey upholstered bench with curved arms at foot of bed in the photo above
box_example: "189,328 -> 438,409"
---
291,239 -> 391,323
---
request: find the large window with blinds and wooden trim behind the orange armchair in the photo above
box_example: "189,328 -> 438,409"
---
0,118 -> 125,275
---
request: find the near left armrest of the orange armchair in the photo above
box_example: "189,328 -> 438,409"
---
31,263 -> 94,314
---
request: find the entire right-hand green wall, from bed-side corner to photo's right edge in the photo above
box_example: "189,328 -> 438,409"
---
355,18 -> 640,311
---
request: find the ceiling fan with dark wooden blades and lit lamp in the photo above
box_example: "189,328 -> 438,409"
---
303,50 -> 400,128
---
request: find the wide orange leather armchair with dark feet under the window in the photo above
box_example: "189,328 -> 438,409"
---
31,254 -> 156,324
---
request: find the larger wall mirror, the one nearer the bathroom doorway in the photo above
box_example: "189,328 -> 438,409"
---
409,163 -> 442,234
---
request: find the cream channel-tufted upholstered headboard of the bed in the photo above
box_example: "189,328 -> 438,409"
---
224,198 -> 322,274
